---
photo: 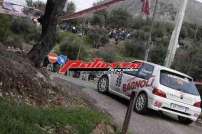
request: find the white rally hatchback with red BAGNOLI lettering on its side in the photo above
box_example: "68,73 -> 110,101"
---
97,60 -> 201,124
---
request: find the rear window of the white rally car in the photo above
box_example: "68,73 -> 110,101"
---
160,70 -> 199,96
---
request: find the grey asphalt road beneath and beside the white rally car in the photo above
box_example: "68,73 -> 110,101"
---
51,74 -> 202,134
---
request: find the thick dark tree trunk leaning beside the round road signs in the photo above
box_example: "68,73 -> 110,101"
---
28,0 -> 66,67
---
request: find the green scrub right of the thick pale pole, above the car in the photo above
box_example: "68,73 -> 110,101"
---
172,23 -> 202,80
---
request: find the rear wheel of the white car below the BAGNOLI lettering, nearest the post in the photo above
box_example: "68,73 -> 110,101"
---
134,93 -> 148,114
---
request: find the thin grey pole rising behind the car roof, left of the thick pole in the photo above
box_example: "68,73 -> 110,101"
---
144,0 -> 158,61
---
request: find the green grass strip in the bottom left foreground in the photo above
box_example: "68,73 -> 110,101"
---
0,98 -> 110,134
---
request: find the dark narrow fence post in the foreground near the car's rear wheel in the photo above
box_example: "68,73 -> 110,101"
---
121,92 -> 135,134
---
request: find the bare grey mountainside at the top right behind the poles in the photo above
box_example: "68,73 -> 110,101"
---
105,0 -> 202,25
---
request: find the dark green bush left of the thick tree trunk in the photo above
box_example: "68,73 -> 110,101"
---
0,15 -> 40,45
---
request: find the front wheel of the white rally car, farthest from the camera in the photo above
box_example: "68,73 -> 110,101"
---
97,76 -> 109,93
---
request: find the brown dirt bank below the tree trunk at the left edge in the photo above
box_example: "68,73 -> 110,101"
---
0,44 -> 74,105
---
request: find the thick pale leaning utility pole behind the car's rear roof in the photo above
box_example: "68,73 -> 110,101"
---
165,0 -> 188,67
